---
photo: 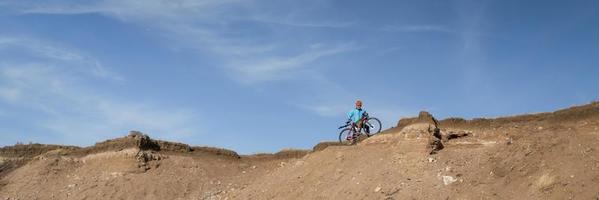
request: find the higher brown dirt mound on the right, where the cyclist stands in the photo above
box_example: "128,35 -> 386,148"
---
229,103 -> 599,199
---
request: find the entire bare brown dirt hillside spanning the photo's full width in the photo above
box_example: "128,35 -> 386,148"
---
0,103 -> 599,199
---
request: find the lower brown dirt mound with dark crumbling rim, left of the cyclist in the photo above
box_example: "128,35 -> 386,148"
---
0,131 -> 308,199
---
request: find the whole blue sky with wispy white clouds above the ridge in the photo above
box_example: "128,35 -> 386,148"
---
0,0 -> 599,154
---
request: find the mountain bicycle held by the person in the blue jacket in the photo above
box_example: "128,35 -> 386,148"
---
338,116 -> 381,145
